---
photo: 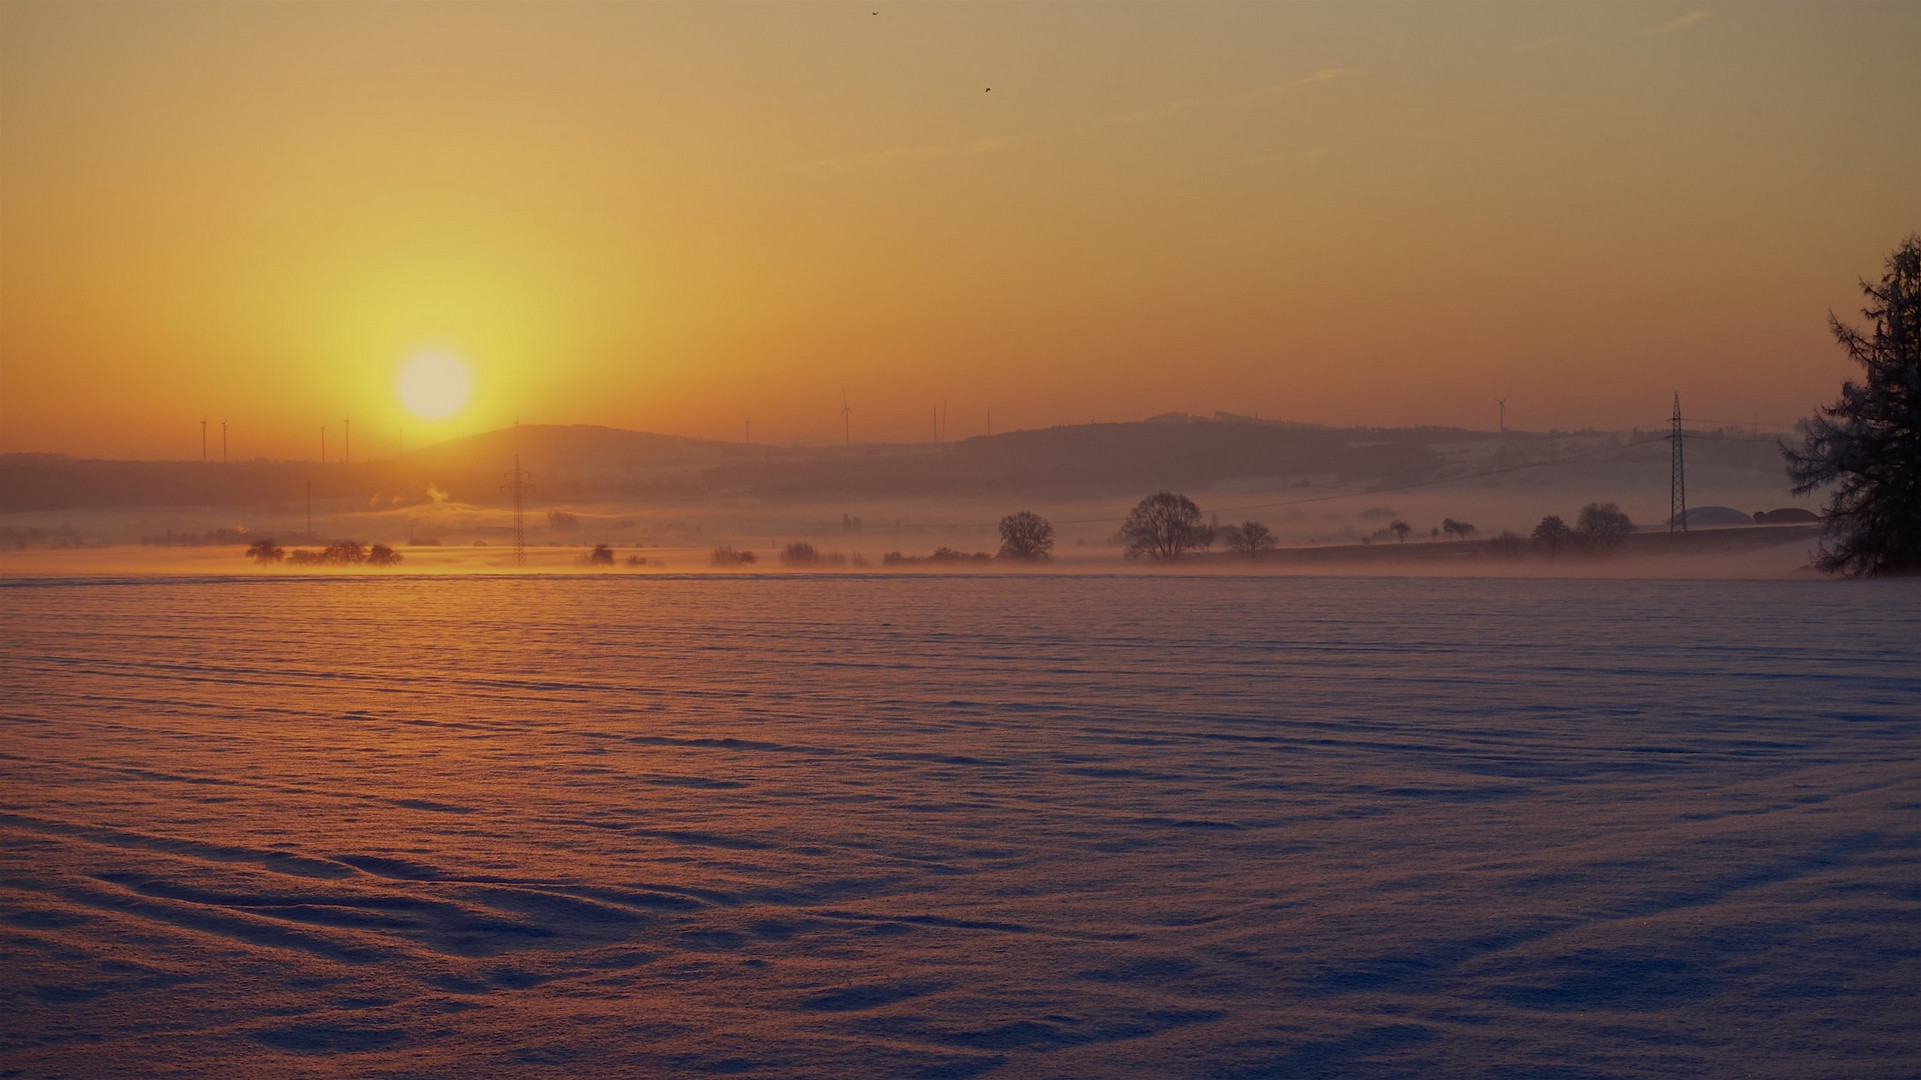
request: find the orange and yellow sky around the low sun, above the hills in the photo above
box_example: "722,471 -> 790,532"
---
0,0 -> 1921,459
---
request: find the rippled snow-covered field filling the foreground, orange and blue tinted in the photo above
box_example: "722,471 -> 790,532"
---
0,575 -> 1921,1078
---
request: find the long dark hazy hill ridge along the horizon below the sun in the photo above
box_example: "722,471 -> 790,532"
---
0,413 -> 1779,513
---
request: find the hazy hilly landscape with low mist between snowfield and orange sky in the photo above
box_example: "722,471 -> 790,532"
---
0,415 -> 1819,577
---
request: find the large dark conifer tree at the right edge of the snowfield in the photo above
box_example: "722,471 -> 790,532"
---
1781,233 -> 1921,575
